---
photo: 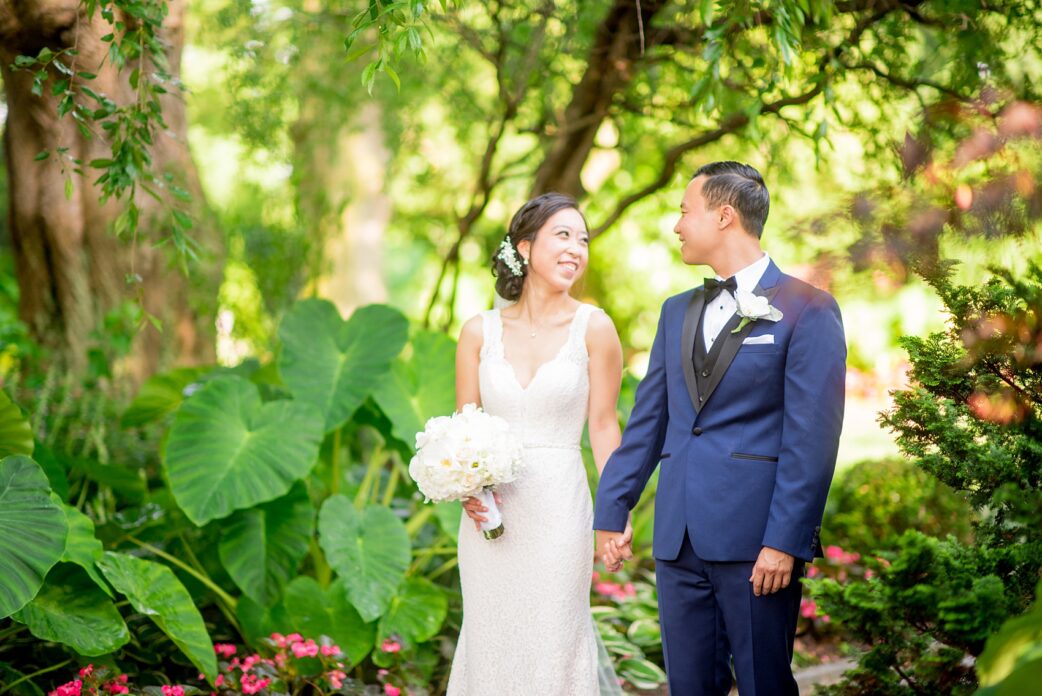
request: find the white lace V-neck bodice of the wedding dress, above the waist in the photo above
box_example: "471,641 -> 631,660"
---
478,304 -> 600,449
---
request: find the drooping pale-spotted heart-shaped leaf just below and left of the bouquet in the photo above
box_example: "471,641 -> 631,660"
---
319,495 -> 412,621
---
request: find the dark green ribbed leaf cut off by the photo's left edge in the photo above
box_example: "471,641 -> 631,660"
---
0,455 -> 69,619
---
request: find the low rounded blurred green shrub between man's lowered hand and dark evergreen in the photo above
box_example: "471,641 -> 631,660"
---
822,459 -> 973,554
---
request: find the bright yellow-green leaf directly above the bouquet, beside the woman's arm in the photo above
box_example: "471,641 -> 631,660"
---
373,331 -> 455,447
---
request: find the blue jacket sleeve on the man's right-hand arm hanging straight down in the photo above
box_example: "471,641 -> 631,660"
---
763,293 -> 846,561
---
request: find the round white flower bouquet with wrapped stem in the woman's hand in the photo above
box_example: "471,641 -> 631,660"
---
408,403 -> 522,539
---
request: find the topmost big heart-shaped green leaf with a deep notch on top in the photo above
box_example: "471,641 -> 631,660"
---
278,299 -> 408,431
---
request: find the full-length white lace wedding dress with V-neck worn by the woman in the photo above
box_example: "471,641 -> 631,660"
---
448,304 -> 621,696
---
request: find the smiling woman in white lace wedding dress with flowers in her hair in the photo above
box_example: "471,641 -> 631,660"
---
448,194 -> 629,696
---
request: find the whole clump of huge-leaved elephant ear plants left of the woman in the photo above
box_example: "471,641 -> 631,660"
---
0,299 -> 458,693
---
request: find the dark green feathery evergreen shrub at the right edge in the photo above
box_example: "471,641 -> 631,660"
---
810,265 -> 1042,694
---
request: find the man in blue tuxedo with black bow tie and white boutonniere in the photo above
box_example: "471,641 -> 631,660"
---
594,161 -> 846,696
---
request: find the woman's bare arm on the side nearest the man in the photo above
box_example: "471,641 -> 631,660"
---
587,312 -> 622,476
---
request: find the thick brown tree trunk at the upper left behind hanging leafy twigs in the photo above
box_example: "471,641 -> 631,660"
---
0,0 -> 218,382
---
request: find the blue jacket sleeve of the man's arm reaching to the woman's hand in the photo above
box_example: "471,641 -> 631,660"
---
593,304 -> 669,531
